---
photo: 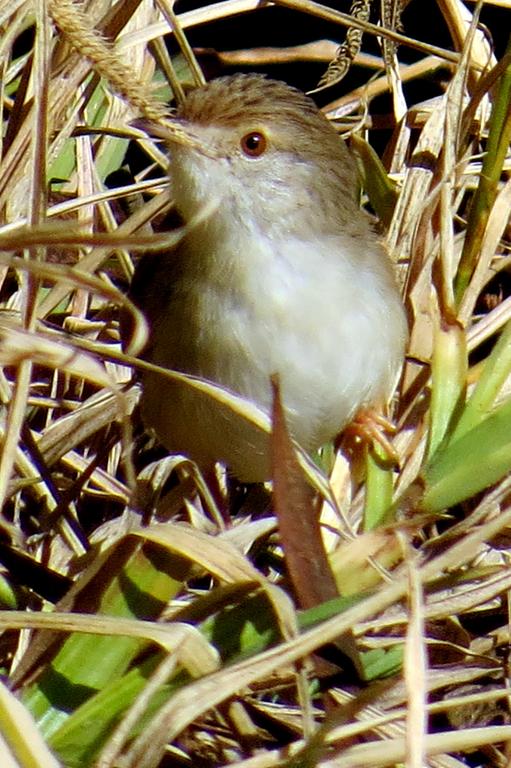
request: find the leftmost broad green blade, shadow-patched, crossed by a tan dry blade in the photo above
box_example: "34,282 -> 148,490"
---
23,539 -> 193,736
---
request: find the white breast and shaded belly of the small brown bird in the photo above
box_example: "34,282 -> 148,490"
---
138,234 -> 406,481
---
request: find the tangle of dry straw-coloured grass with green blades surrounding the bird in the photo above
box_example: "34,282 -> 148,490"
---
0,0 -> 511,768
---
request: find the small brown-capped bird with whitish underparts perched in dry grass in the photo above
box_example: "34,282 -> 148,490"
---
130,74 -> 407,482
